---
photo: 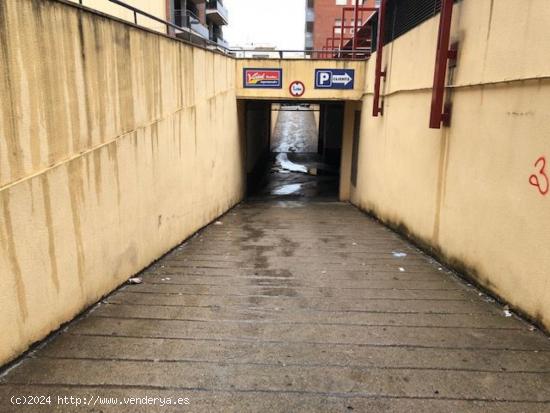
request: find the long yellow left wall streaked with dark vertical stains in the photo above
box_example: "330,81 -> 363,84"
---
0,0 -> 244,365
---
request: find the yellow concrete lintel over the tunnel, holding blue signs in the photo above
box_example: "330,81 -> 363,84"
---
235,59 -> 366,100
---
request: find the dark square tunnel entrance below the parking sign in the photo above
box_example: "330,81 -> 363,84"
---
245,101 -> 344,200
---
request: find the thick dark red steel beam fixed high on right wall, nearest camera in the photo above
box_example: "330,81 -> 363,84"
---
430,0 -> 456,129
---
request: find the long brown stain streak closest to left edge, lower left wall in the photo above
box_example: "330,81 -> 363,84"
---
0,191 -> 29,327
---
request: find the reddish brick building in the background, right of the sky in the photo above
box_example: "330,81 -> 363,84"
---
305,0 -> 380,55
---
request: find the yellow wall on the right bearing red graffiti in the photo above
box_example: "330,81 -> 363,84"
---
351,0 -> 550,329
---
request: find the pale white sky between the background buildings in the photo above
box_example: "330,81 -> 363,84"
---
223,0 -> 306,50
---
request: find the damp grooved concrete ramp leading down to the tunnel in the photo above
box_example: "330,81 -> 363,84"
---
0,201 -> 550,413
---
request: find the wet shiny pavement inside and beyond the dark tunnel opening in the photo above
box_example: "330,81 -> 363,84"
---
249,106 -> 339,201
